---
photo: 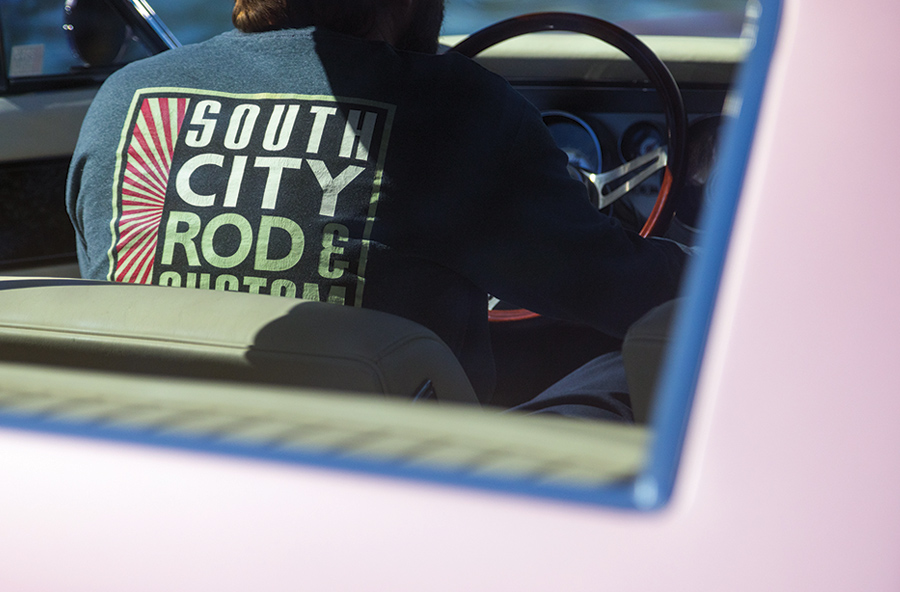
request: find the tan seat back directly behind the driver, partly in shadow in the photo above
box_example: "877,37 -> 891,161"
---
0,278 -> 477,403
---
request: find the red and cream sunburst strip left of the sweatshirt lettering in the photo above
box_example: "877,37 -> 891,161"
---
114,97 -> 190,284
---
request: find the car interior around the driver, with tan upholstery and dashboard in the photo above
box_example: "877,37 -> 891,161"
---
0,0 -> 753,500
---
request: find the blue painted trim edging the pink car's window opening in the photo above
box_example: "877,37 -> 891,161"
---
0,0 -> 781,509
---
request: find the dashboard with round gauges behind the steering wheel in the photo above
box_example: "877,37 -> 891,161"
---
443,32 -> 750,245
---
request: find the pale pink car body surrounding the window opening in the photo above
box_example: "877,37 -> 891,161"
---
0,0 -> 900,591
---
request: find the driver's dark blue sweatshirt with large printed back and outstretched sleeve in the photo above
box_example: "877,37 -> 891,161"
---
68,0 -> 682,396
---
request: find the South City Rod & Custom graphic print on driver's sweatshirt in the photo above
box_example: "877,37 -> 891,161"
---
109,88 -> 393,306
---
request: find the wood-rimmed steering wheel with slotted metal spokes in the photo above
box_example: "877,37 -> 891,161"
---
450,12 -> 688,322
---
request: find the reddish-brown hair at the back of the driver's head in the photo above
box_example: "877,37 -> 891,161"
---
231,0 -> 387,37
